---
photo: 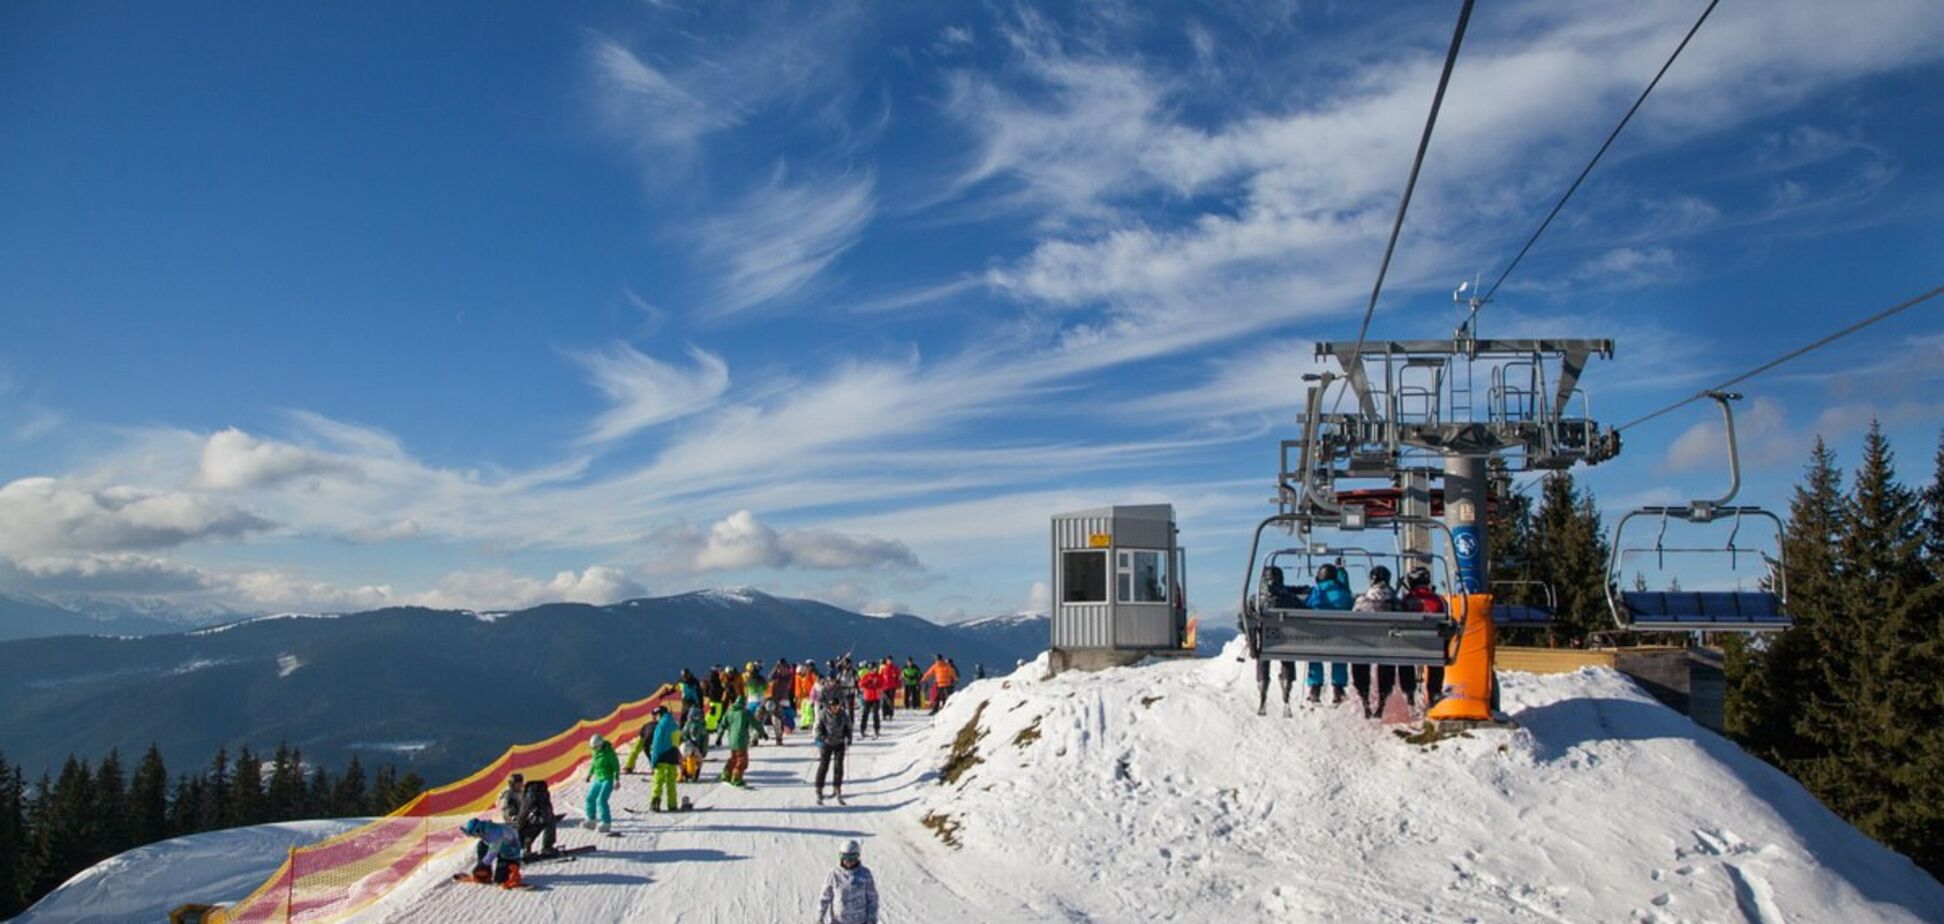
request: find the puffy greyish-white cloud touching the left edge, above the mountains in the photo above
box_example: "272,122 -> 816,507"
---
0,477 -> 272,558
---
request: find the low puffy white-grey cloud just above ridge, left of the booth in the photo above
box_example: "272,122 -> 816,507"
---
649,510 -> 920,574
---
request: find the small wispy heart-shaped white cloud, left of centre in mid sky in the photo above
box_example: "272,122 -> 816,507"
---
579,344 -> 729,444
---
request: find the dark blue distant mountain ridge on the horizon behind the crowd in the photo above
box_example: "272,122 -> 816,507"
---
0,587 -> 1046,782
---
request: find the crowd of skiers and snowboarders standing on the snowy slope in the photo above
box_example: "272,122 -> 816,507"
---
461,654 -> 986,924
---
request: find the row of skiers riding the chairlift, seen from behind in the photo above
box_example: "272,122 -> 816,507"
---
1260,564 -> 1444,718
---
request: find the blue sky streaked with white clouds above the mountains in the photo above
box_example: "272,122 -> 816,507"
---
0,0 -> 1944,619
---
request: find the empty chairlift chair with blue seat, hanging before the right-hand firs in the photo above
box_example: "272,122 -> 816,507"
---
1606,391 -> 1794,632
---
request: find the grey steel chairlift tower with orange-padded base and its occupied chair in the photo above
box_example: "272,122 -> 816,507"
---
1242,319 -> 1619,722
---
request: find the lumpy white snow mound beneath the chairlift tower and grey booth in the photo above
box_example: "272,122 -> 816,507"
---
908,642 -> 1944,922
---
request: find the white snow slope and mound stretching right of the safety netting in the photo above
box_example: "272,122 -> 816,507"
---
334,650 -> 1944,924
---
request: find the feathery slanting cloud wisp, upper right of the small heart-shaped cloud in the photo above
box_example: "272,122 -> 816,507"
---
698,169 -> 877,315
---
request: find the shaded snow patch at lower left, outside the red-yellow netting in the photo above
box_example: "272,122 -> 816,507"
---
14,819 -> 367,924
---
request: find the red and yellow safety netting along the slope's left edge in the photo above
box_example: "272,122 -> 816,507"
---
208,687 -> 675,924
